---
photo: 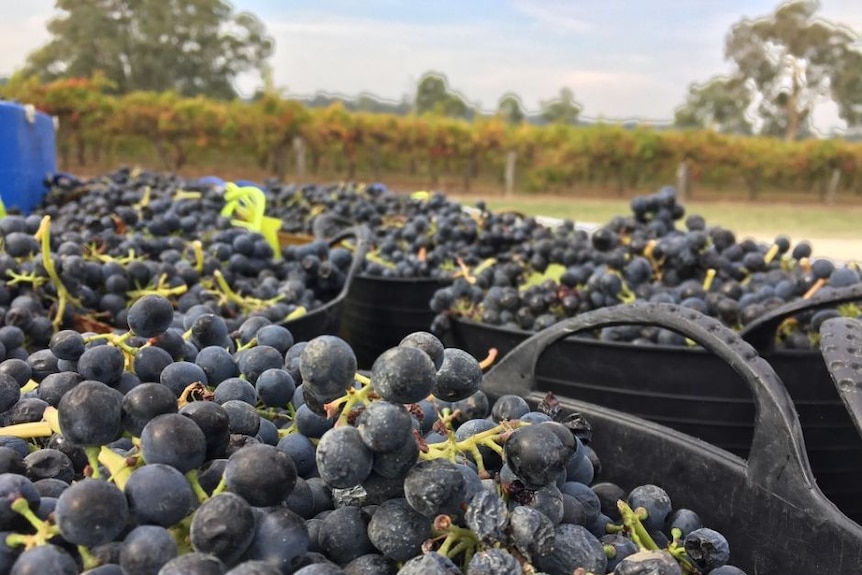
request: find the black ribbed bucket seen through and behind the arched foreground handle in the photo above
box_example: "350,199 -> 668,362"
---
445,286 -> 862,522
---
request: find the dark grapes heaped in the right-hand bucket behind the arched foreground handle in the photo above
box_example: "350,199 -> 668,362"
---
429,188 -> 862,350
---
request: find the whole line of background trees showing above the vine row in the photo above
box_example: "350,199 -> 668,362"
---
10,0 -> 862,140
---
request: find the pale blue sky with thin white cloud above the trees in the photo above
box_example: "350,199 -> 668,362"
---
0,0 -> 862,132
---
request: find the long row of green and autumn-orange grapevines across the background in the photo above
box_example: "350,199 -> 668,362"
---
5,76 -> 862,202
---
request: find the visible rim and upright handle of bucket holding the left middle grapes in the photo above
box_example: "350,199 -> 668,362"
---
281,226 -> 371,341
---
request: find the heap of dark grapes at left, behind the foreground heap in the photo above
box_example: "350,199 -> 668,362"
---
0,169 -> 362,346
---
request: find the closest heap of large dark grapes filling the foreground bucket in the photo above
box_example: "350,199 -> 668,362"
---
0,288 -> 738,575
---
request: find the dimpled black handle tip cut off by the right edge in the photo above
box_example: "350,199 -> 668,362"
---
820,317 -> 862,433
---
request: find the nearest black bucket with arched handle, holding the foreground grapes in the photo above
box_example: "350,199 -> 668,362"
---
483,304 -> 862,575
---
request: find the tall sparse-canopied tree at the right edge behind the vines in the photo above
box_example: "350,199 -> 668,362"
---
682,0 -> 862,140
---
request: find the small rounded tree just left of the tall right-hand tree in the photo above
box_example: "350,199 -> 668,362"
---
674,77 -> 753,135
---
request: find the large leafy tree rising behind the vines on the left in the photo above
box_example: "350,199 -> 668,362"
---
24,0 -> 273,98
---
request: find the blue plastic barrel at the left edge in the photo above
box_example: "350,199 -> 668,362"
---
0,102 -> 57,214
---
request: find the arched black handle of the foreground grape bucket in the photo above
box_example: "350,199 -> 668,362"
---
483,303 -> 823,508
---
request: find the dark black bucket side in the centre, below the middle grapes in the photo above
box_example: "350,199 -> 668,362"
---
341,275 -> 451,369
